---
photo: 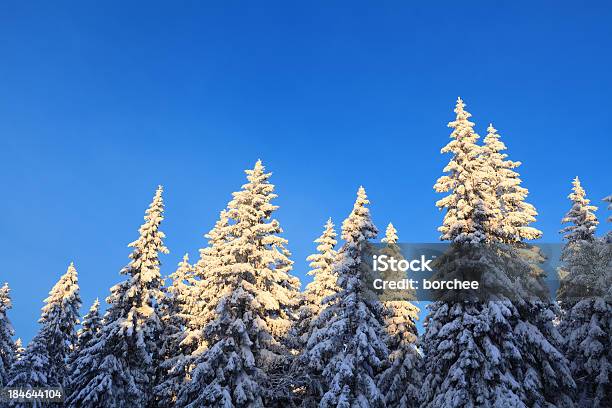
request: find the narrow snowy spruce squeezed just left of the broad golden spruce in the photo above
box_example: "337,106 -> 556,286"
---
155,254 -> 193,408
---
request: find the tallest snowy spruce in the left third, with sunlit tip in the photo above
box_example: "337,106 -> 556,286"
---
66,186 -> 168,408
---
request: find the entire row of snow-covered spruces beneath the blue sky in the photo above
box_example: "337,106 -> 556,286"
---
0,99 -> 612,408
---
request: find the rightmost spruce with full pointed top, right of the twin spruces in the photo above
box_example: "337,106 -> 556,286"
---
557,179 -> 612,408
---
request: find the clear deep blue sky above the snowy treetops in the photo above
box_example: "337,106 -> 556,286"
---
0,1 -> 612,340
